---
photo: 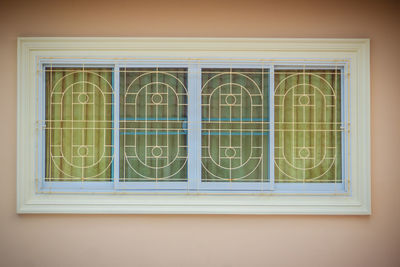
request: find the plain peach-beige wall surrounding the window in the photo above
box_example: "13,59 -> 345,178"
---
0,0 -> 400,267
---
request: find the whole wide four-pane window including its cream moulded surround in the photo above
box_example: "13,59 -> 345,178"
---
18,38 -> 370,214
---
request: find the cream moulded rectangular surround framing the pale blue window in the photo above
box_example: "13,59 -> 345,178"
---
17,37 -> 371,214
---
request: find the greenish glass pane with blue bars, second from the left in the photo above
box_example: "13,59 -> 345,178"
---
119,68 -> 188,182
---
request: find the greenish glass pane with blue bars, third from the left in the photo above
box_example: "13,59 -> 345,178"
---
201,68 -> 269,182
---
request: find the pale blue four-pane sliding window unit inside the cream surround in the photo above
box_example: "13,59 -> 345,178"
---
38,60 -> 349,193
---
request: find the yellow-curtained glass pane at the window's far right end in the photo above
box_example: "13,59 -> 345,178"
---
275,69 -> 343,183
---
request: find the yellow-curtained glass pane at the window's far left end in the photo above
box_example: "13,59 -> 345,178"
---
44,67 -> 113,182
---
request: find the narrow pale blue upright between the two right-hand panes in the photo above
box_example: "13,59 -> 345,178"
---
268,66 -> 275,190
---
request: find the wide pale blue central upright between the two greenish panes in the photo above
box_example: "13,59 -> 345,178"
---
187,64 -> 201,190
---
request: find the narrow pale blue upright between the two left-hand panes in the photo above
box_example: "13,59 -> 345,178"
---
112,65 -> 120,189
